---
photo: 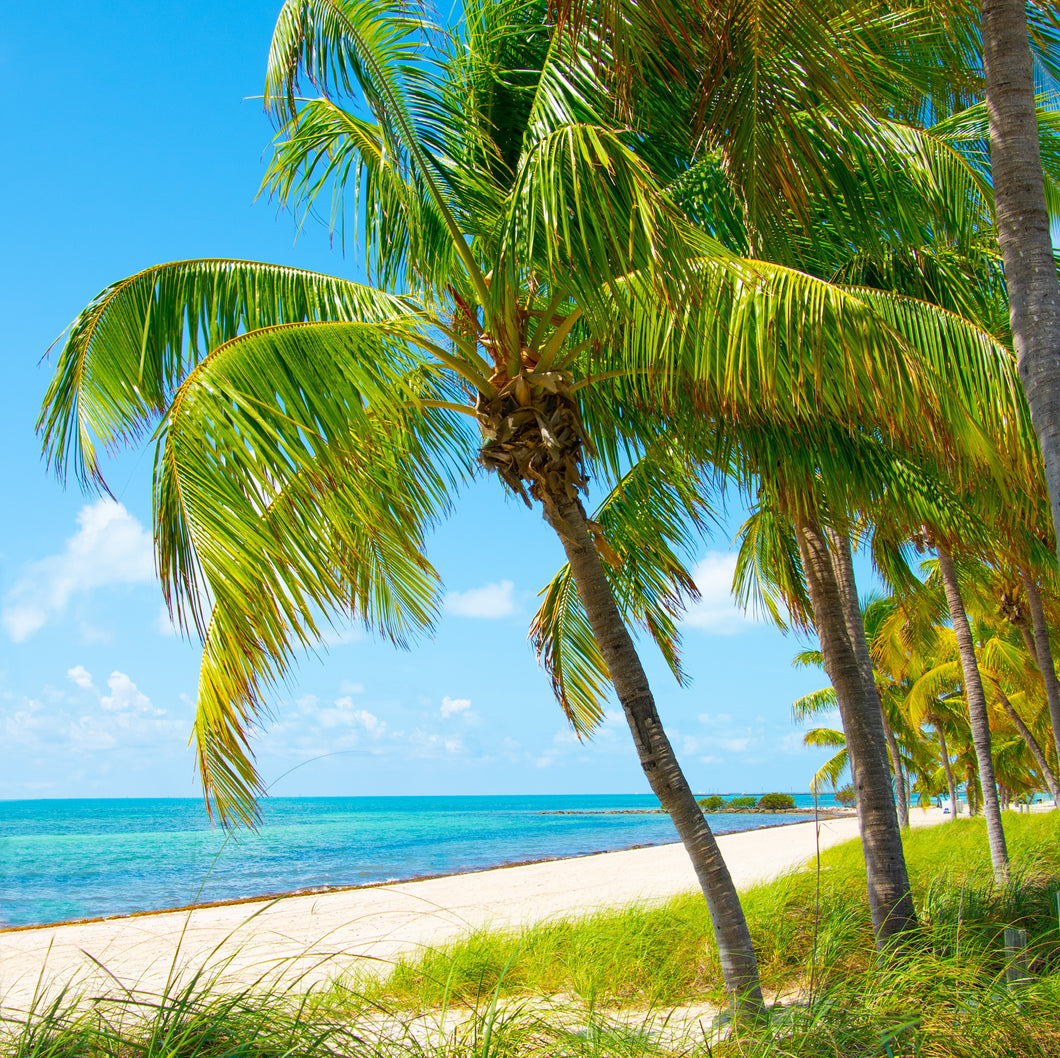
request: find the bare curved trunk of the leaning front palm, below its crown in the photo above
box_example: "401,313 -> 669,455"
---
542,490 -> 765,1020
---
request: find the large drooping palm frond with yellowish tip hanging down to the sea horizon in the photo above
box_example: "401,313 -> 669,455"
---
156,323 -> 474,821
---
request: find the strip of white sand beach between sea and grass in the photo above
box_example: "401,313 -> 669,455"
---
0,809 -> 944,1009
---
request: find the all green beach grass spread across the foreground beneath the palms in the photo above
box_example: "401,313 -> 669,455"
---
6,812 -> 1060,1058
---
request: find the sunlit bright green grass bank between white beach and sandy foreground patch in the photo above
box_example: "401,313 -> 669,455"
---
341,812 -> 1060,1007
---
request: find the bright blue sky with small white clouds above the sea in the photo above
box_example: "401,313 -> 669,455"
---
0,0 -> 843,798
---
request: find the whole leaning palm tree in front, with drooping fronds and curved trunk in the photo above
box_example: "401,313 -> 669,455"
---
40,0 -> 1034,1016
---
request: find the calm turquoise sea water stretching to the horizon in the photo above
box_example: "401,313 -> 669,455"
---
0,795 -> 831,925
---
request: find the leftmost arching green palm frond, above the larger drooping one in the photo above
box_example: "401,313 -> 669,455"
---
37,260 -> 417,488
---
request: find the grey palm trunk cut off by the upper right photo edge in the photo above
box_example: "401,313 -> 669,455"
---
981,0 -> 1060,572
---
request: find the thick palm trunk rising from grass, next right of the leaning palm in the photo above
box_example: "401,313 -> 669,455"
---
795,516 -> 917,950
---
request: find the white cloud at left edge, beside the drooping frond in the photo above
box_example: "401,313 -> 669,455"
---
2,499 -> 155,642
